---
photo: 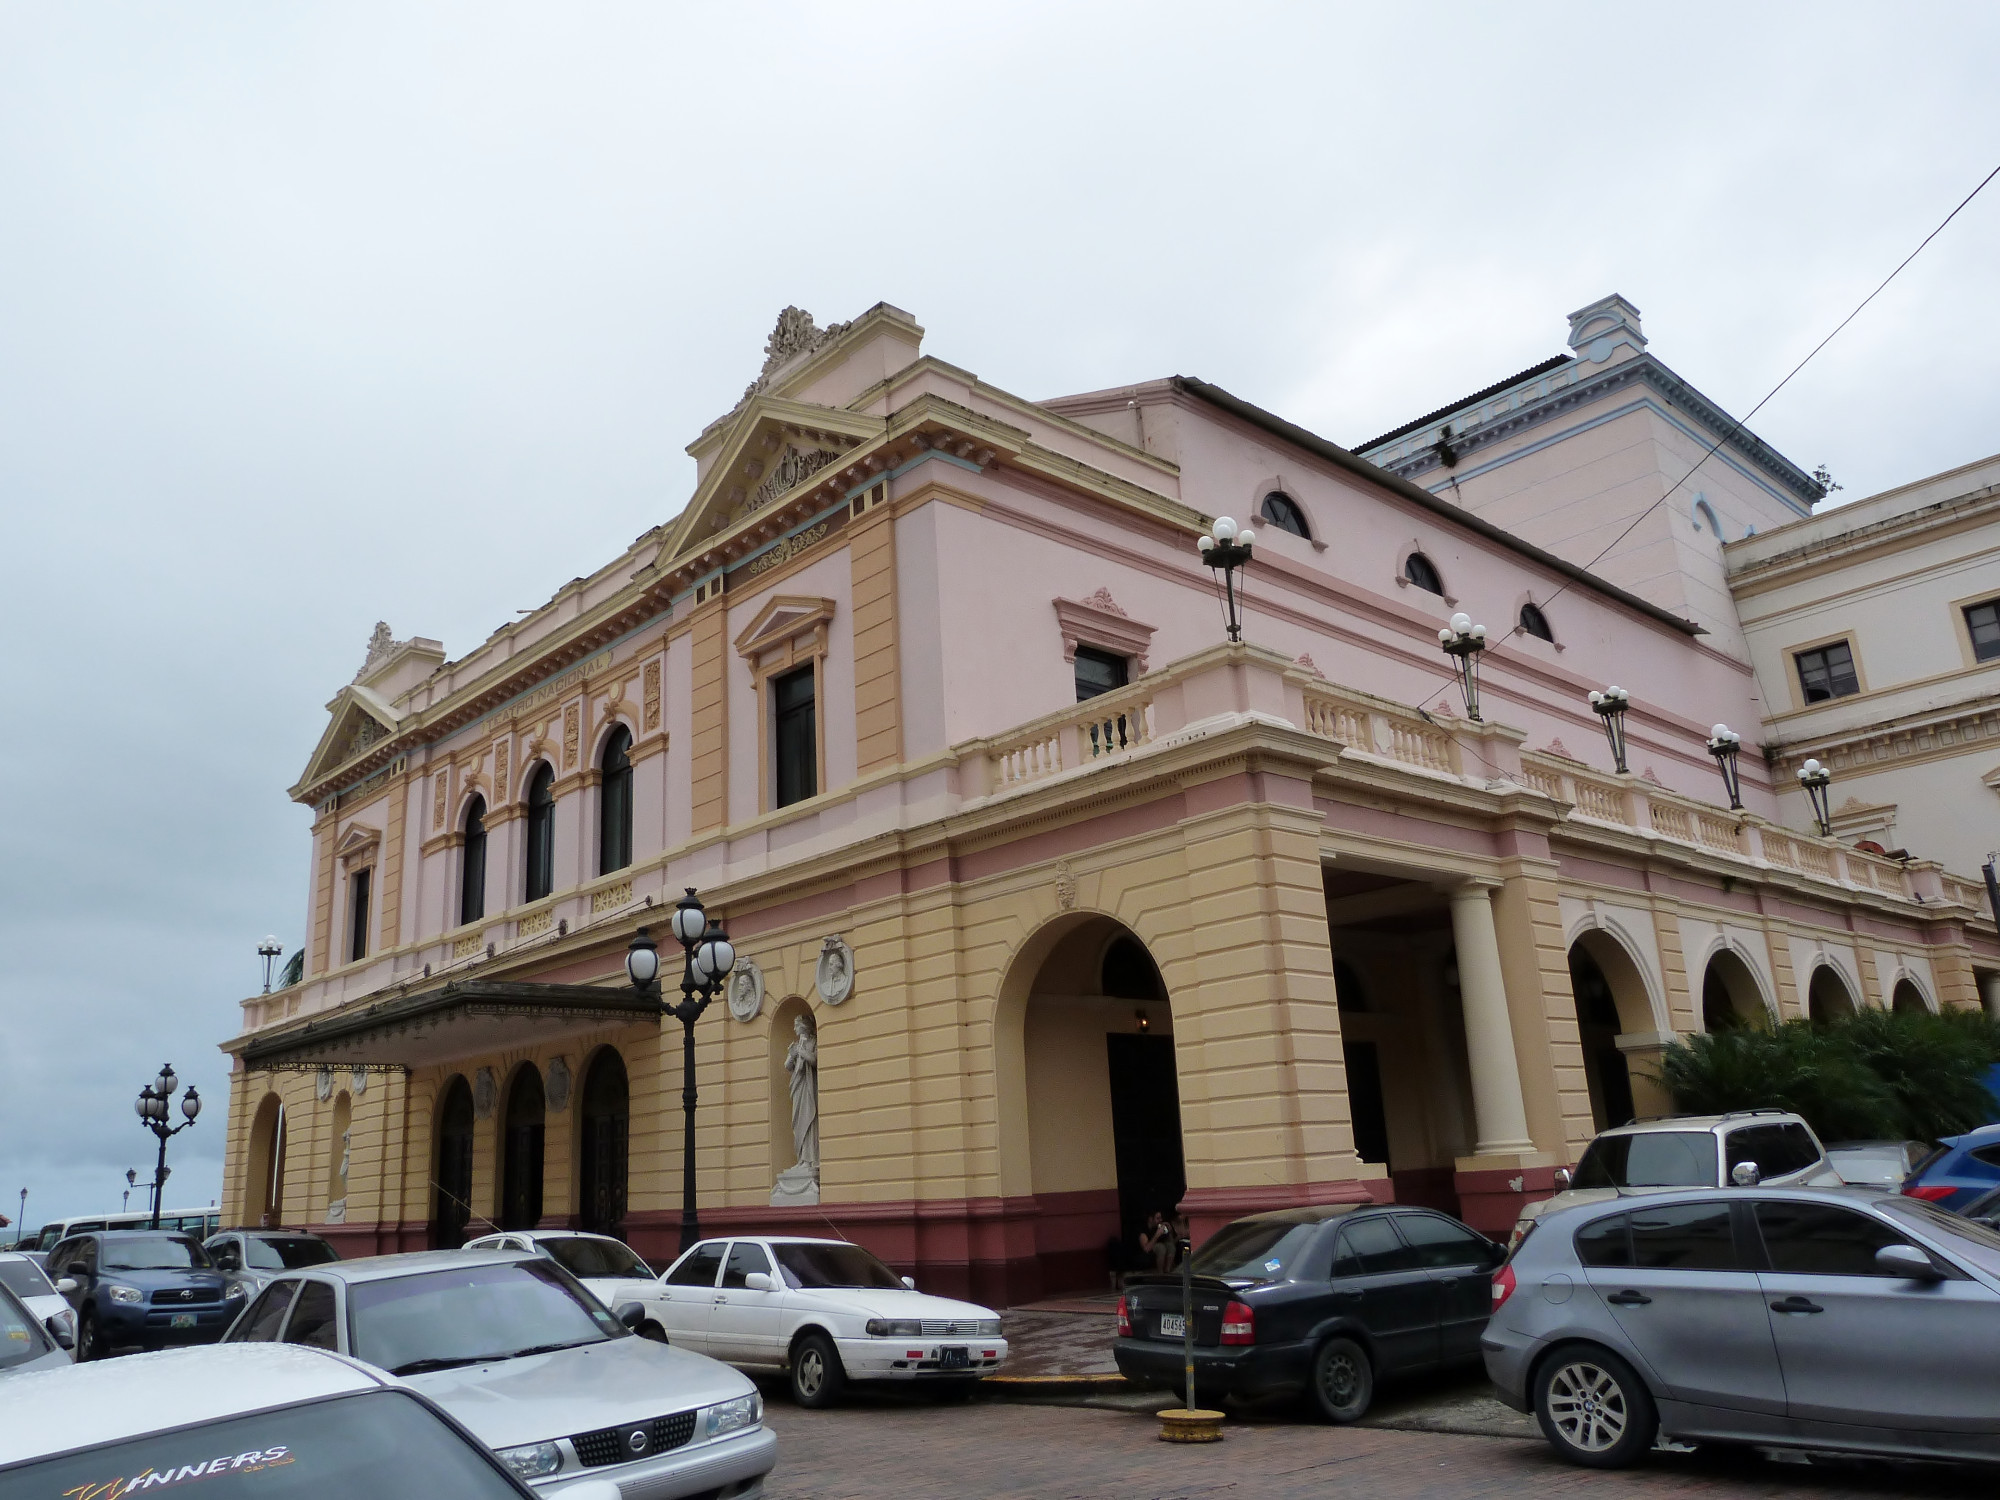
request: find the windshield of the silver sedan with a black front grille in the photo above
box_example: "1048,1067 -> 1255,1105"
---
348,1260 -> 626,1374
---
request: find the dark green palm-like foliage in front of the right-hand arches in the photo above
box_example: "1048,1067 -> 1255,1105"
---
1660,1008 -> 2000,1140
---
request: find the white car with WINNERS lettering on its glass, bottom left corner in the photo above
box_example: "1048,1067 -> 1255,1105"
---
0,1344 -> 600,1500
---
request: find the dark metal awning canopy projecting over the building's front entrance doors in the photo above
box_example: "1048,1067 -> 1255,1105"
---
242,980 -> 660,1072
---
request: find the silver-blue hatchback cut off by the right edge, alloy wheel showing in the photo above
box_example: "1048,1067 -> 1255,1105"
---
1482,1188 -> 2000,1468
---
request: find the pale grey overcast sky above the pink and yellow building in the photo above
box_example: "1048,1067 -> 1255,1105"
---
0,0 -> 2000,1222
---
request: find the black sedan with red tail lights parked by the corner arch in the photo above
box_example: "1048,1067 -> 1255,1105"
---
1114,1204 -> 1506,1422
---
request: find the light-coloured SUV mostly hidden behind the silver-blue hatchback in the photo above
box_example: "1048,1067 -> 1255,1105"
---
1508,1110 -> 1840,1250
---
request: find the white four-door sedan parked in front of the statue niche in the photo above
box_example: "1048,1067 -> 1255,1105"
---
664,1236 -> 1006,1406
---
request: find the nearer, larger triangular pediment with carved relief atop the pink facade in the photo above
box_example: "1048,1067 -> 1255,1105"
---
658,396 -> 888,566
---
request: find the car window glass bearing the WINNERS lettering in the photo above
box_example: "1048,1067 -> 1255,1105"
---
0,1390 -> 520,1500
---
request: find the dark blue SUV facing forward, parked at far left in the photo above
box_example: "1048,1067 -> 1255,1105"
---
46,1230 -> 244,1360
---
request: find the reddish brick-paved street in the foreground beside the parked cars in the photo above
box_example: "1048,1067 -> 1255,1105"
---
766,1394 -> 1992,1500
